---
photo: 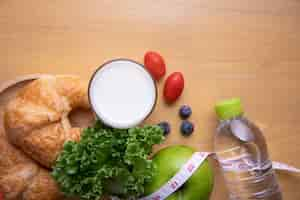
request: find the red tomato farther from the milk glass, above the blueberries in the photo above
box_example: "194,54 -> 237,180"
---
164,72 -> 184,103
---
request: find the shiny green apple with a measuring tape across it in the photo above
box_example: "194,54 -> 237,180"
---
145,145 -> 214,200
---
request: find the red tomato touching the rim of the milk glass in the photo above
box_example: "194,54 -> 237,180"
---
144,51 -> 166,80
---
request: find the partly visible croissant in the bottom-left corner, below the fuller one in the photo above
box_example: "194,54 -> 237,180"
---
0,136 -> 63,200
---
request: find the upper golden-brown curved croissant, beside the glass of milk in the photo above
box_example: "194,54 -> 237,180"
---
4,76 -> 89,168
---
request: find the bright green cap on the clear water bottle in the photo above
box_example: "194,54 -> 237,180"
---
215,98 -> 243,120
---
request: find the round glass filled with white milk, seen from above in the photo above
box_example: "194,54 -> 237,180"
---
88,59 -> 157,129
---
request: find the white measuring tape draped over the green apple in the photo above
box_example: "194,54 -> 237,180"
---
139,152 -> 300,200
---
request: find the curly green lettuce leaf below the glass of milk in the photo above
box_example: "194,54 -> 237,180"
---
52,121 -> 164,200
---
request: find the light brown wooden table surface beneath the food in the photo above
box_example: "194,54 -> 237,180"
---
0,0 -> 300,200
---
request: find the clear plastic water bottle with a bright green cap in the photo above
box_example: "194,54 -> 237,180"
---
214,98 -> 282,200
